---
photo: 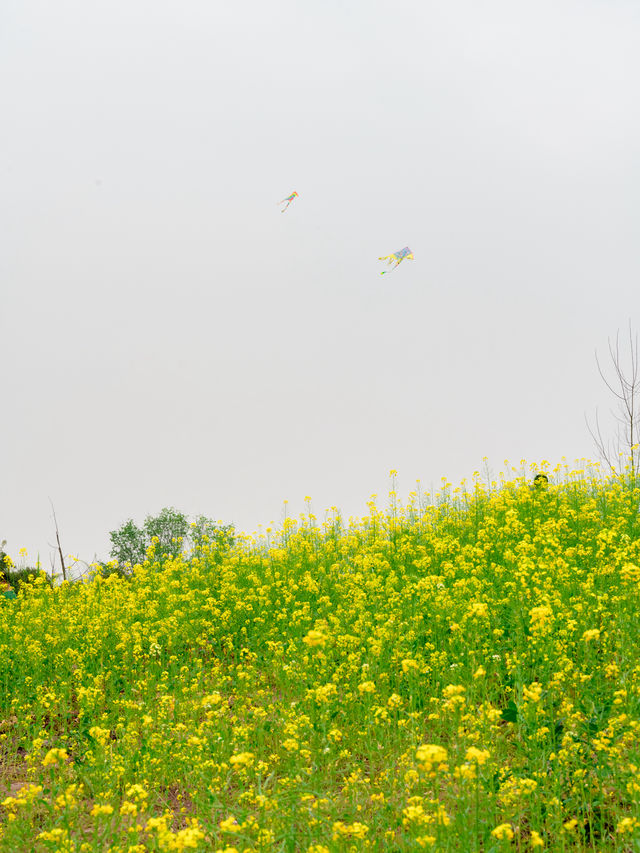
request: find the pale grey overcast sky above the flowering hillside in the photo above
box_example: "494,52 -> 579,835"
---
0,0 -> 640,565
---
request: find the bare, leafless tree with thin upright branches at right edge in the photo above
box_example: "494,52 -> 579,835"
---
587,322 -> 640,479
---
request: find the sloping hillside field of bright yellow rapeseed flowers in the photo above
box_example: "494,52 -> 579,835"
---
0,471 -> 640,853
